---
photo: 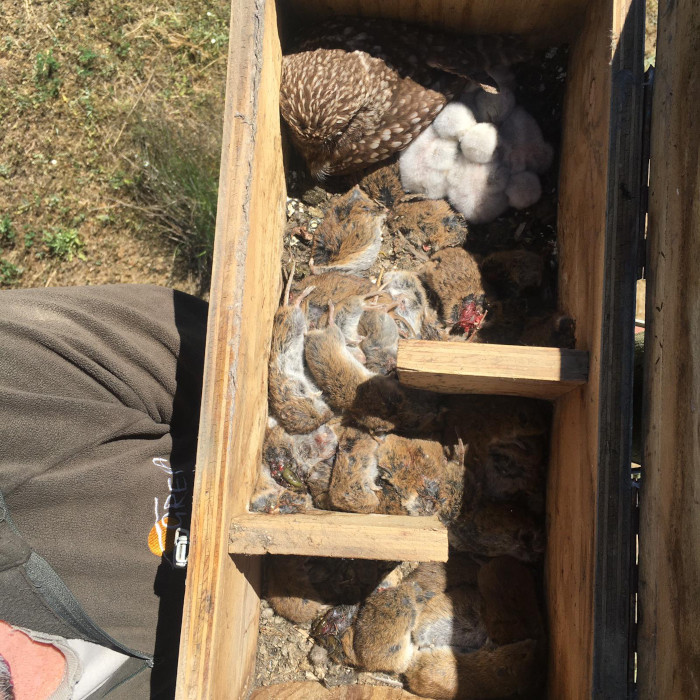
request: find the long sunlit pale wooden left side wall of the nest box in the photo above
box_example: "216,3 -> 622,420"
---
177,0 -> 285,699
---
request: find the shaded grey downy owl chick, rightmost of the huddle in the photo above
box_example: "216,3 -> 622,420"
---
501,107 -> 554,173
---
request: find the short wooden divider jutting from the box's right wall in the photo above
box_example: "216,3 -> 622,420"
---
396,340 -> 588,399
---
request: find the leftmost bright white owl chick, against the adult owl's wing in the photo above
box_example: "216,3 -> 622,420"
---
399,127 -> 457,199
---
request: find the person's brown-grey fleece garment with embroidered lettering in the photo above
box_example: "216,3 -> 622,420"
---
0,285 -> 207,698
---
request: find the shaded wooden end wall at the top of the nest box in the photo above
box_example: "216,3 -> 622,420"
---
281,0 -> 587,43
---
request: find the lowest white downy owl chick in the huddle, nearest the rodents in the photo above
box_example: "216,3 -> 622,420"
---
447,158 -> 510,224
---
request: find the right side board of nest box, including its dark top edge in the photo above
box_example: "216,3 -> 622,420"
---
545,0 -> 643,698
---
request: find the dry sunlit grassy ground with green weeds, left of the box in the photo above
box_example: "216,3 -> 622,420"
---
0,0 -> 658,297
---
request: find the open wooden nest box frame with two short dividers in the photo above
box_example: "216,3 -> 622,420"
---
178,0 -> 698,700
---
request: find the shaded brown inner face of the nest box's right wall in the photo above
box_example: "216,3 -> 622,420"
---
545,0 -> 628,700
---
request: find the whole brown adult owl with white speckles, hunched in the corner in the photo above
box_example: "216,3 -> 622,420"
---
280,17 -> 525,178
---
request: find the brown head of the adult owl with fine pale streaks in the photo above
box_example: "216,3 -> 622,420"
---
280,49 -> 386,179
